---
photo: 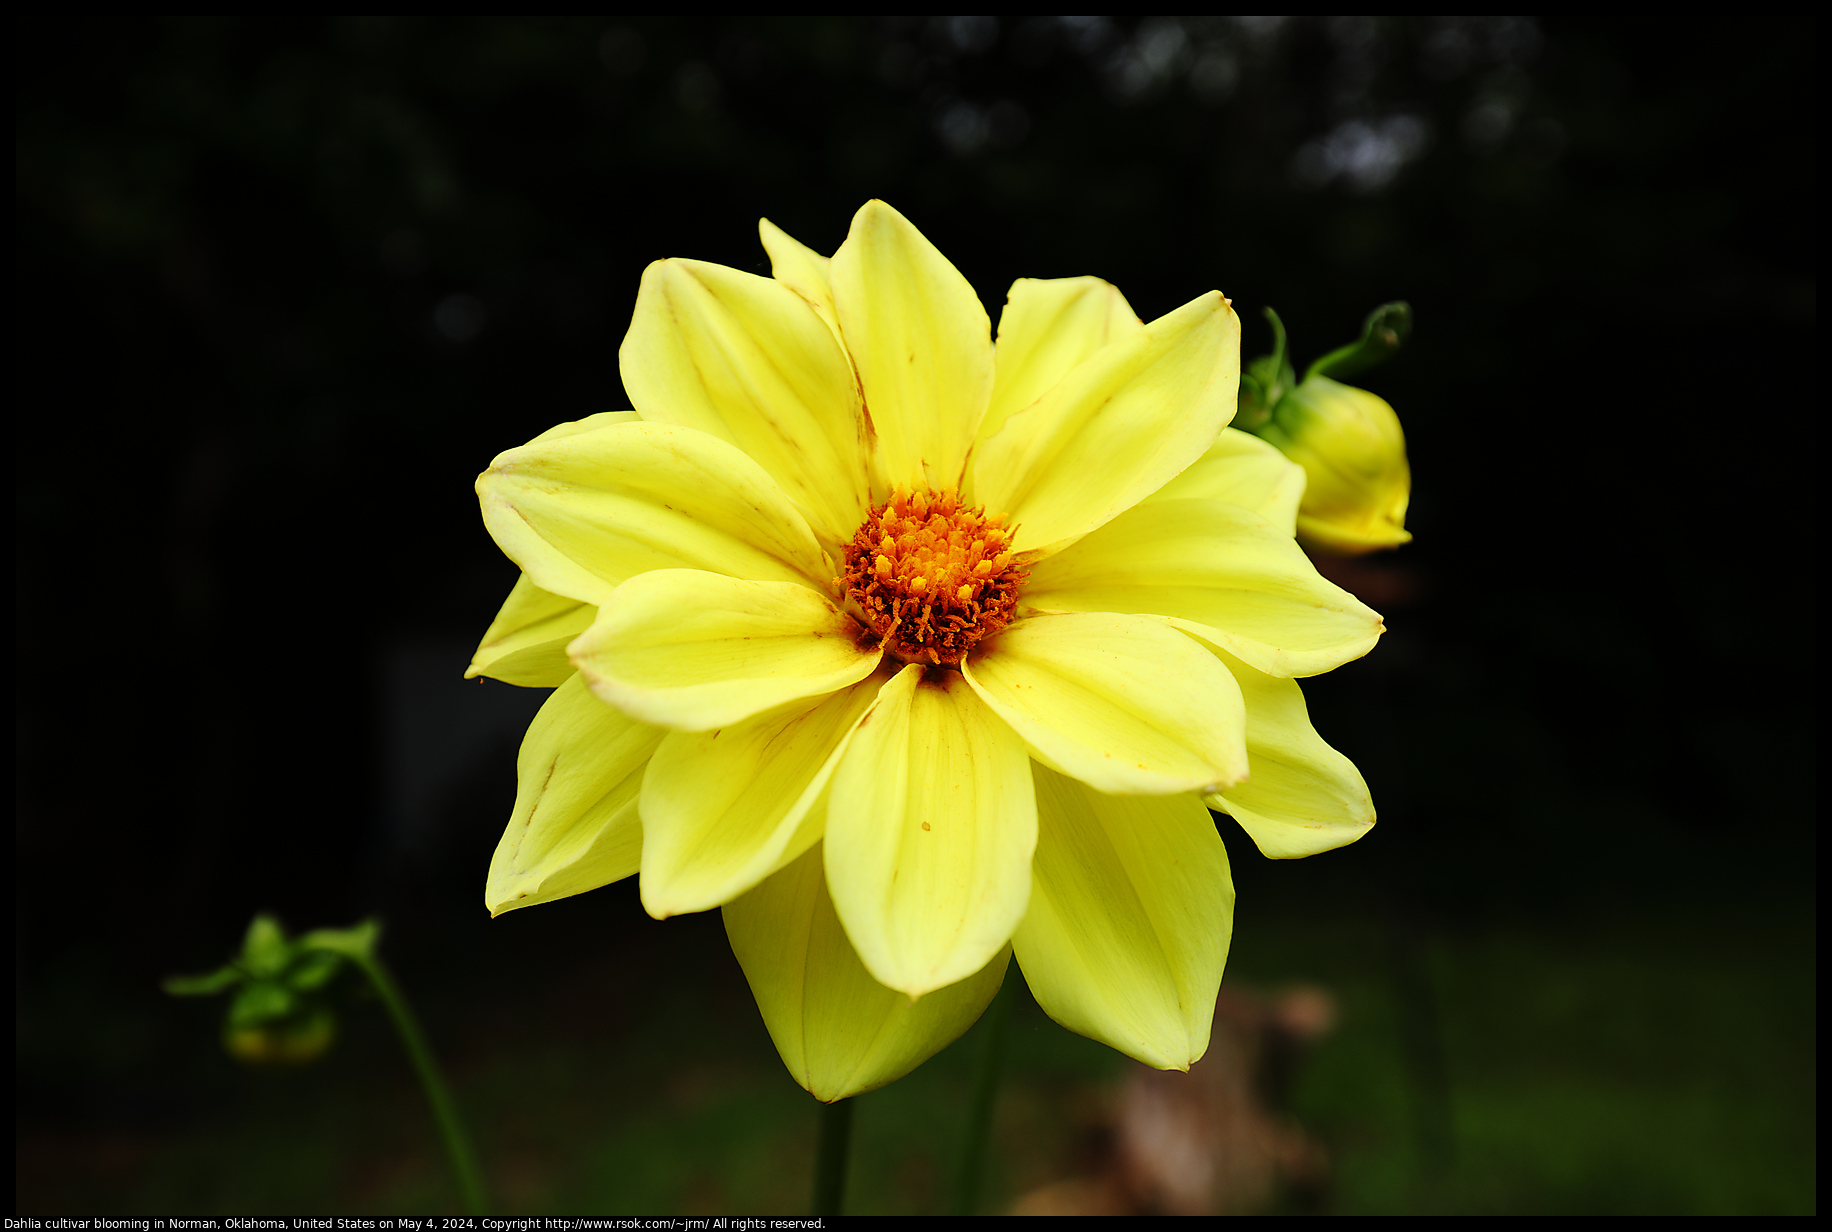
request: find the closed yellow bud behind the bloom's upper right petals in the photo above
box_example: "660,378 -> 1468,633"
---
1260,376 -> 1412,556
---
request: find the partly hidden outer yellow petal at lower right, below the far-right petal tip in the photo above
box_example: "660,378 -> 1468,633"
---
1204,651 -> 1374,860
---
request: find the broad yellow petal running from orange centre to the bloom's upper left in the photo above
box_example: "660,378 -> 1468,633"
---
619,260 -> 867,543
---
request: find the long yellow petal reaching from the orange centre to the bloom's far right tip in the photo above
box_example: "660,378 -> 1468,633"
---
1024,501 -> 1383,677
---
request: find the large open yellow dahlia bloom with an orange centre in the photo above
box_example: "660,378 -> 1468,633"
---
471,202 -> 1381,1100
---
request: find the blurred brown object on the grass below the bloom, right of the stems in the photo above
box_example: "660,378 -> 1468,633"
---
1011,986 -> 1336,1216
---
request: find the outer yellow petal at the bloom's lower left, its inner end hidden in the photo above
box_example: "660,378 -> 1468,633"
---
484,677 -> 663,915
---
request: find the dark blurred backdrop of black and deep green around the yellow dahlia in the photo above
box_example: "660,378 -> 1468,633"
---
15,18 -> 1817,1214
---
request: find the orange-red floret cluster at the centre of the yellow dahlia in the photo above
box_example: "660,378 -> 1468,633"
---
834,490 -> 1030,667
